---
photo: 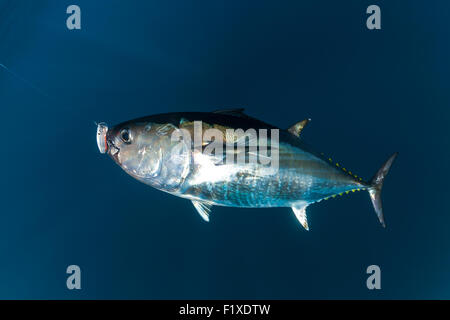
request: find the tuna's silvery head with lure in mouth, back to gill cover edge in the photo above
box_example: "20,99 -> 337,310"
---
97,117 -> 191,192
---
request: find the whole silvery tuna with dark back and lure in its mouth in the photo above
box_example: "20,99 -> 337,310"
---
97,109 -> 397,230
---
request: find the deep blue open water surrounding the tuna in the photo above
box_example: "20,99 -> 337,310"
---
0,0 -> 450,299
